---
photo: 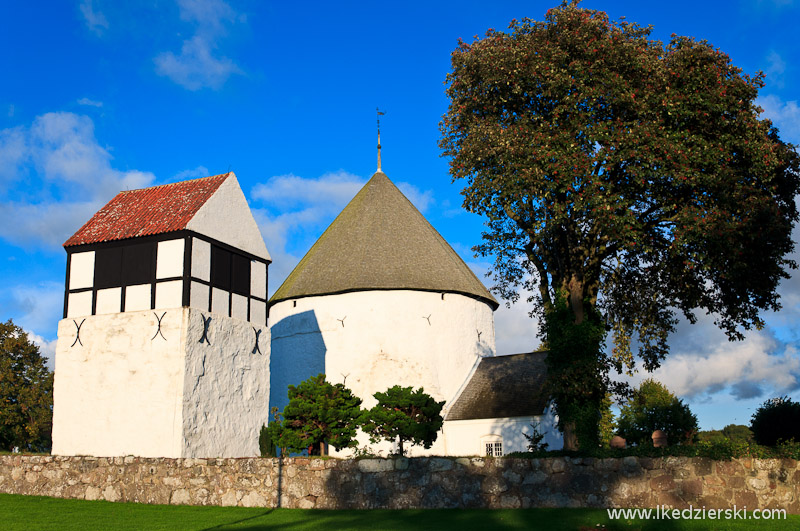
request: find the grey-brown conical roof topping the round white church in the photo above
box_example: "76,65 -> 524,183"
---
270,171 -> 498,309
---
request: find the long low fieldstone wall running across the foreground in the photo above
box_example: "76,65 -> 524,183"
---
0,455 -> 800,514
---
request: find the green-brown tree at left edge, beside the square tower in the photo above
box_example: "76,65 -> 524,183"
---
0,319 -> 53,452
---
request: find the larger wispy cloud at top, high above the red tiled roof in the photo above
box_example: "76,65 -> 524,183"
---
154,0 -> 244,90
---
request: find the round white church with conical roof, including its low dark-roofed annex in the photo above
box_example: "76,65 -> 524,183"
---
269,170 -> 560,455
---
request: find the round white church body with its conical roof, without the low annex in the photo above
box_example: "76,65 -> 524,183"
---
270,168 -> 498,455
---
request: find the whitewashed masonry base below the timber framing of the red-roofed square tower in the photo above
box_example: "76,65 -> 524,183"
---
53,308 -> 270,457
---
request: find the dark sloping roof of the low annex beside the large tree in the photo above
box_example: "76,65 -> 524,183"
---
445,352 -> 547,420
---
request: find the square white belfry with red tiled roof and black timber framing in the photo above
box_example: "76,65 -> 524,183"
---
53,173 -> 270,457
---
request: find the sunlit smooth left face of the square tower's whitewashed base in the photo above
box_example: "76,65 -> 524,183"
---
53,310 -> 185,457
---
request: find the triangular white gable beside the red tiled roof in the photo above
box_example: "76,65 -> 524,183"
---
186,173 -> 270,262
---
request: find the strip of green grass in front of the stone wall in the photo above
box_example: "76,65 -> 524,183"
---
0,494 -> 800,531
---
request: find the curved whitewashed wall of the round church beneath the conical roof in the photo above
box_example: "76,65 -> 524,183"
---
270,290 -> 495,455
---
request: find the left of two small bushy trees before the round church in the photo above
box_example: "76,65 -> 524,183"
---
276,374 -> 361,452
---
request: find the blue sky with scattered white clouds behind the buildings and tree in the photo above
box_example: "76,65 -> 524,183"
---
0,0 -> 800,428
